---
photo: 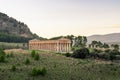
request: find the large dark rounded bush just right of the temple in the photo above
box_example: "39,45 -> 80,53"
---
72,48 -> 90,59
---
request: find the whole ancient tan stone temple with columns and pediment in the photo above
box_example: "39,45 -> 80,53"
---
29,38 -> 71,52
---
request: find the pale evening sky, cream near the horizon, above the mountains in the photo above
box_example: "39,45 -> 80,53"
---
0,0 -> 120,38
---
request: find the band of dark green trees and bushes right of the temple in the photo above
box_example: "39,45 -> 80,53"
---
65,35 -> 120,61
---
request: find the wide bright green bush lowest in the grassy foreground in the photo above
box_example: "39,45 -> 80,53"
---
32,68 -> 47,76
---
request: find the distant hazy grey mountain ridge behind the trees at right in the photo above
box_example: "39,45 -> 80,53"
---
87,33 -> 120,43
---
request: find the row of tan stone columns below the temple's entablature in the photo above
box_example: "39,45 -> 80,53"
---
29,42 -> 71,52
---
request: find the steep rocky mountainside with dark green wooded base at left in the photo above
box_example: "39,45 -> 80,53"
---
0,12 -> 44,42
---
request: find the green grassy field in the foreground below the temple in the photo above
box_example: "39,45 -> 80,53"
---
0,50 -> 120,80
